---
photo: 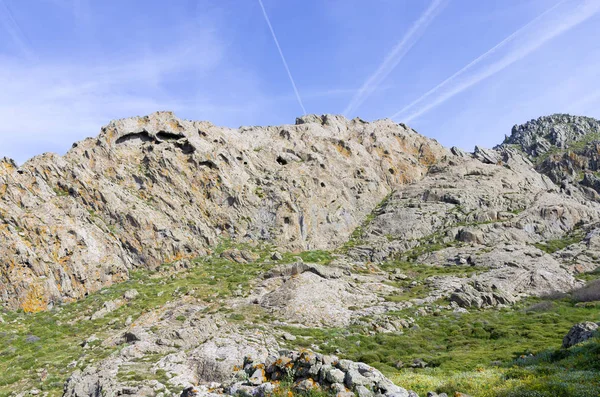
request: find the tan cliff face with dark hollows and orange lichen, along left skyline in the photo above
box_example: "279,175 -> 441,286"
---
0,112 -> 448,311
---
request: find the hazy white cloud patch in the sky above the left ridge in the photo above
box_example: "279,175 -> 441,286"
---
0,15 -> 261,163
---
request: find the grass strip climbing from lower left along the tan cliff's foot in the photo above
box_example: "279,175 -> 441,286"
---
0,243 -> 284,396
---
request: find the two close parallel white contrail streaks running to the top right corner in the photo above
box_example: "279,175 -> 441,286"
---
391,0 -> 600,122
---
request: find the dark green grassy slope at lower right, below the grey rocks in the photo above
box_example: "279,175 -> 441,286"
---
287,300 -> 600,396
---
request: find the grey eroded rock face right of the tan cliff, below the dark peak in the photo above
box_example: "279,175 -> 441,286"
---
349,135 -> 600,308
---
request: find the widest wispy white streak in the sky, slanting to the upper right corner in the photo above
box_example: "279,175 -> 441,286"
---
391,0 -> 600,122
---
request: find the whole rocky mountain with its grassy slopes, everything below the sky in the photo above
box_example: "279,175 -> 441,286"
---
0,112 -> 600,397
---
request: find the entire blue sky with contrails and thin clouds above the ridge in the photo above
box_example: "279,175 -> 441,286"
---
0,0 -> 600,163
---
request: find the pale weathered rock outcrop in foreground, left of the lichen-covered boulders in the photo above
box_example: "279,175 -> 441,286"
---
64,300 -> 278,397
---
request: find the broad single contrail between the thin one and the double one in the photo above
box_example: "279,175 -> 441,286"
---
344,0 -> 446,116
